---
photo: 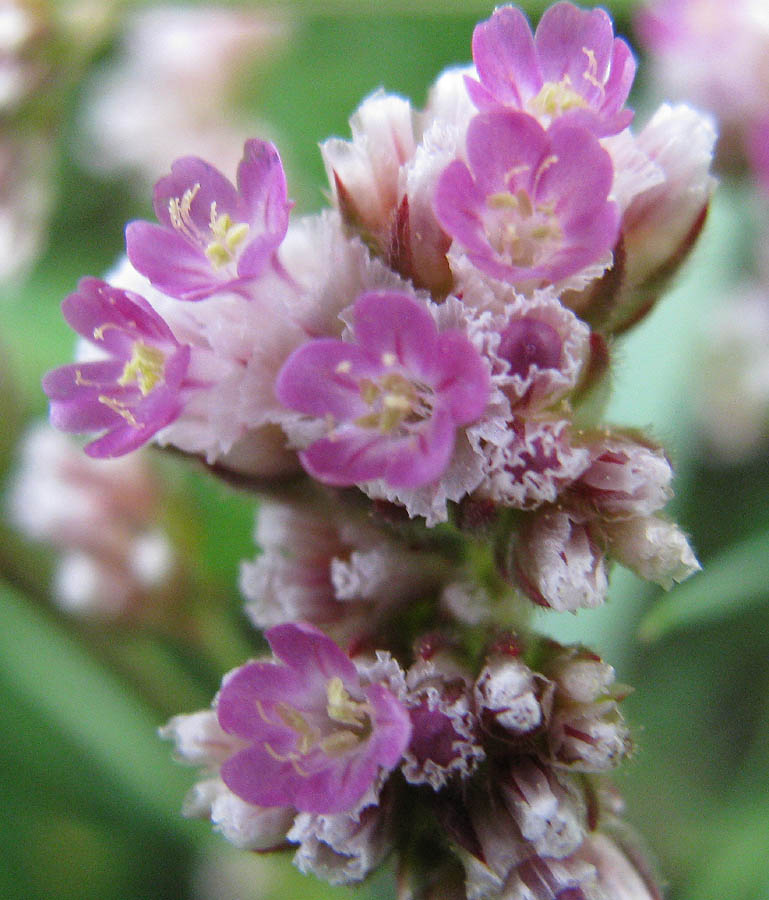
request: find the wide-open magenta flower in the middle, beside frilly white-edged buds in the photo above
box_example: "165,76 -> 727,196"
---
276,291 -> 489,488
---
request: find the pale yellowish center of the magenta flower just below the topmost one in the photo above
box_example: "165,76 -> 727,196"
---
486,188 -> 563,268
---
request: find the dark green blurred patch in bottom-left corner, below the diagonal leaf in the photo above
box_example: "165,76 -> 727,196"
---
0,677 -> 192,900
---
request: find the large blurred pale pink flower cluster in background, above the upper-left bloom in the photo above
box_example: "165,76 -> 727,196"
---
76,4 -> 291,186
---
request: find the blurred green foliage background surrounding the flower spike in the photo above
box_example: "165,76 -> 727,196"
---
0,0 -> 769,900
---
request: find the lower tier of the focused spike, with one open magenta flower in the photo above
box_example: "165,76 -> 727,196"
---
162,624 -> 658,900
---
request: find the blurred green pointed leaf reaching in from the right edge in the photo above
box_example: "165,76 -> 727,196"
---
639,532 -> 769,641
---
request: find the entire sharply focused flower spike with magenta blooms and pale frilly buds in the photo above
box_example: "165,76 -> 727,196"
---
44,2 -> 715,900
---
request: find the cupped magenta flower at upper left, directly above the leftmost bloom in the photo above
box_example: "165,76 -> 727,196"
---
126,140 -> 291,300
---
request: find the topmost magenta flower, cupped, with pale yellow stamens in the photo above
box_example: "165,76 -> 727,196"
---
467,3 -> 635,137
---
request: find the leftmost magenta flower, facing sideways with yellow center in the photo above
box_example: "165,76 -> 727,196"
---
43,278 -> 190,457
